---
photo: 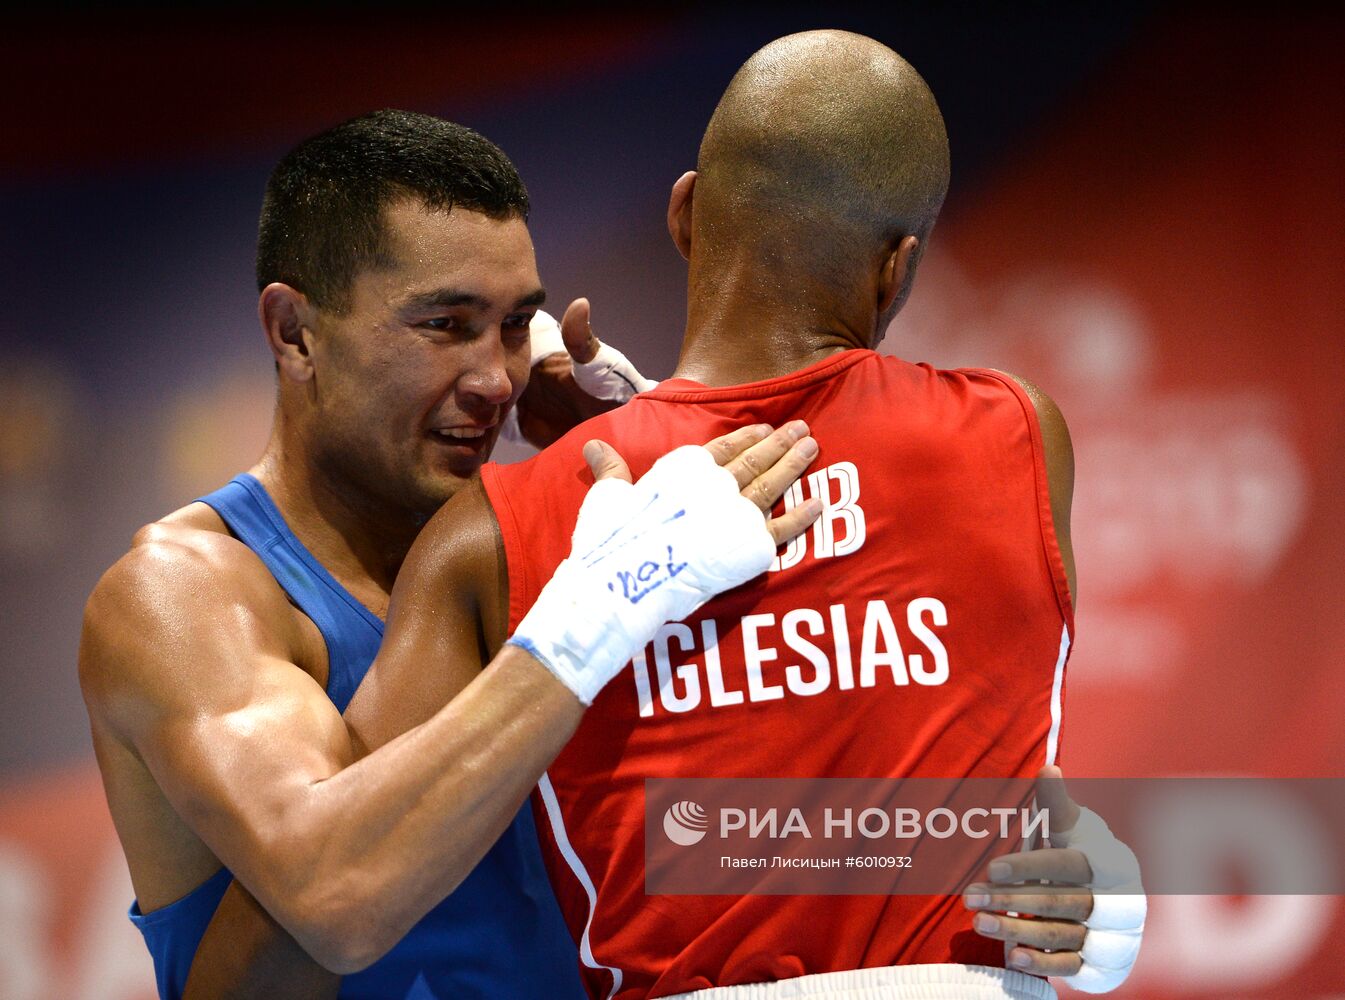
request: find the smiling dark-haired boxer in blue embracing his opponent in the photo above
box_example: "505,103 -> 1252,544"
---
79,112 -> 815,997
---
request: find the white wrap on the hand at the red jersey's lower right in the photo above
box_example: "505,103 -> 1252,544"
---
1050,809 -> 1149,993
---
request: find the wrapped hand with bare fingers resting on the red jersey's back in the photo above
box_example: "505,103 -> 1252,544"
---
510,421 -> 820,704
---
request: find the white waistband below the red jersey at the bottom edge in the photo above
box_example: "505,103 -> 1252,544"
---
668,965 -> 1056,1000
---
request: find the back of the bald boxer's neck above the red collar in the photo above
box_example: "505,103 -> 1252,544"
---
674,248 -> 878,386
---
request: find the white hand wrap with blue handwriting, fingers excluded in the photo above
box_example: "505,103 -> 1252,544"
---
508,445 -> 775,705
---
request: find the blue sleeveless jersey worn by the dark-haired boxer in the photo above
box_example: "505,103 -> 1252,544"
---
130,474 -> 584,1000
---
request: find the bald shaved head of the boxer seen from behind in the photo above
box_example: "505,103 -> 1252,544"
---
695,31 -> 948,270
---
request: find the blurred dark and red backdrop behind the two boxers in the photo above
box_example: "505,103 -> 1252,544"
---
0,7 -> 1345,1000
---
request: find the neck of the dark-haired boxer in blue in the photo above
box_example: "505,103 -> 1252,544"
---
249,416 -> 425,594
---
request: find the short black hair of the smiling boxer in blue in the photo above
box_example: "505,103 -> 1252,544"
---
257,109 -> 529,312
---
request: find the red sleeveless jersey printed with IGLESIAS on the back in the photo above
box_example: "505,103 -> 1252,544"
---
482,350 -> 1073,997
